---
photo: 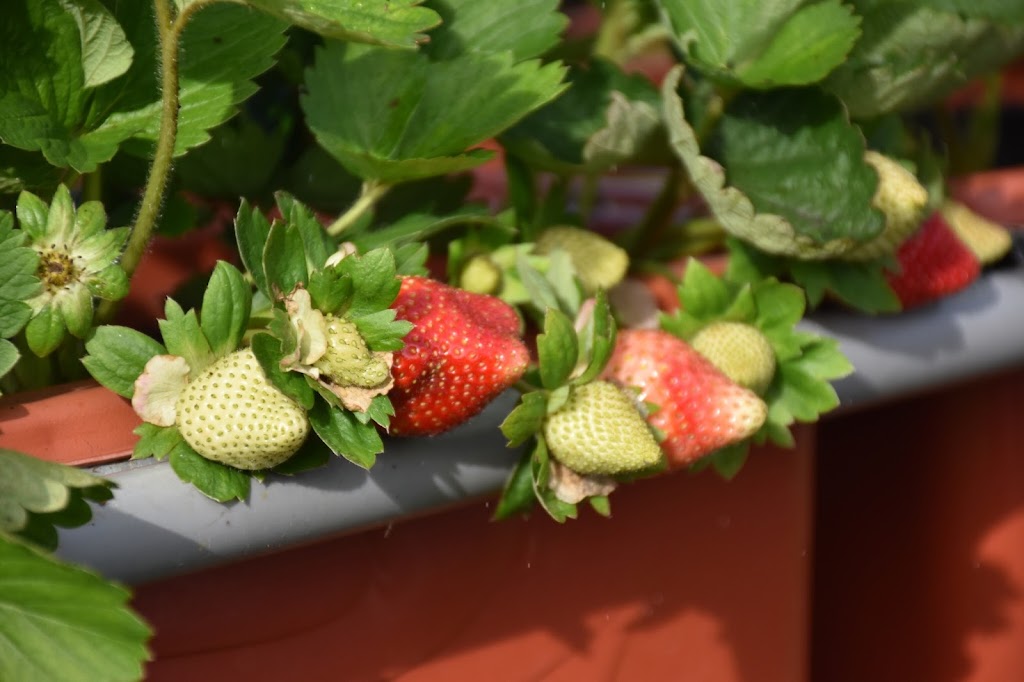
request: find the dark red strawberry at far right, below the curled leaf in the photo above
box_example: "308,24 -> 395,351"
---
888,212 -> 981,309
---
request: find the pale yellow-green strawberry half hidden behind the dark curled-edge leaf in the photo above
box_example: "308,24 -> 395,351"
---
842,151 -> 928,260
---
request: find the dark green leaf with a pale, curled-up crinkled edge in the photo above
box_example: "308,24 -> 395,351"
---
664,69 -> 885,258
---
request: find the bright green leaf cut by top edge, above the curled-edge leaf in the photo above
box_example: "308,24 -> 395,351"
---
659,0 -> 860,88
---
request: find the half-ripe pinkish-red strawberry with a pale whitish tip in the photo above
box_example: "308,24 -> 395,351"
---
602,329 -> 768,466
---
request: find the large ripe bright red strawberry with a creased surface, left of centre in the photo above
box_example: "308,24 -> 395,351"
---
388,276 -> 529,435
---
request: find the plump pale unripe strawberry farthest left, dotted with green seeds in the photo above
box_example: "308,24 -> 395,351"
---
175,348 -> 309,469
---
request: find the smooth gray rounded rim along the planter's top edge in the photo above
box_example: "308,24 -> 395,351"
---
58,268 -> 1024,584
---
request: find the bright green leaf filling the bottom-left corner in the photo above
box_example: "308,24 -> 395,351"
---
0,535 -> 152,682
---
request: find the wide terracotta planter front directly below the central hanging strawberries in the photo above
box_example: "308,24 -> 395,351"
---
135,429 -> 814,682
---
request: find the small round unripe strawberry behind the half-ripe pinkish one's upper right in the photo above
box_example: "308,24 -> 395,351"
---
690,321 -> 775,395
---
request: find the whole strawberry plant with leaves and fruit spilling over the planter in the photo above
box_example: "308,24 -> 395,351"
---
0,0 -> 1024,680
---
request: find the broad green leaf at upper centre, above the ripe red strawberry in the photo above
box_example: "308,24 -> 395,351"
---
301,43 -> 563,184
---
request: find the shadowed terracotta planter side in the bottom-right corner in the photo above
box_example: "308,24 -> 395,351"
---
812,369 -> 1024,682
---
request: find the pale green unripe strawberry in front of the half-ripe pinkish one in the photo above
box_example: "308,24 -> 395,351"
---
544,381 -> 663,476
